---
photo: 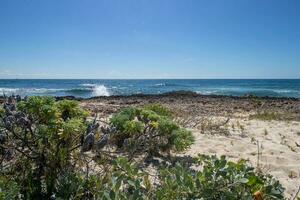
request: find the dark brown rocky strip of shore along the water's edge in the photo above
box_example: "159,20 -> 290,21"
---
74,92 -> 300,121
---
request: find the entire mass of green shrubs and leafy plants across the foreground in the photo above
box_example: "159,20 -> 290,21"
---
0,96 -> 284,200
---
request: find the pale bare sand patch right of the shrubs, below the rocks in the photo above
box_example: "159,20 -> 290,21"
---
179,118 -> 300,197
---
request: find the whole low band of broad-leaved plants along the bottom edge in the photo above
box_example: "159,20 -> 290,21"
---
50,155 -> 284,200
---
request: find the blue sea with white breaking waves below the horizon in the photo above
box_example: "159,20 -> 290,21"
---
0,79 -> 300,98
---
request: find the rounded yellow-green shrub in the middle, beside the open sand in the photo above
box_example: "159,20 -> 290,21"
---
110,104 -> 194,154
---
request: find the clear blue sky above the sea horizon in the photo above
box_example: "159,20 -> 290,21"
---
0,0 -> 300,78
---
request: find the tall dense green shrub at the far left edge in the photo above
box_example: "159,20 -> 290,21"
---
0,97 -> 87,199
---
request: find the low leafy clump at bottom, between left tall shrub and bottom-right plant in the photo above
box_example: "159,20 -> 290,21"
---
50,157 -> 152,200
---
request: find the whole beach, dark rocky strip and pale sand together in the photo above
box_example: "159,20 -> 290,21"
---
79,92 -> 300,198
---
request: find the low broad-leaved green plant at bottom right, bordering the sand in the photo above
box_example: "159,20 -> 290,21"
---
157,155 -> 284,199
